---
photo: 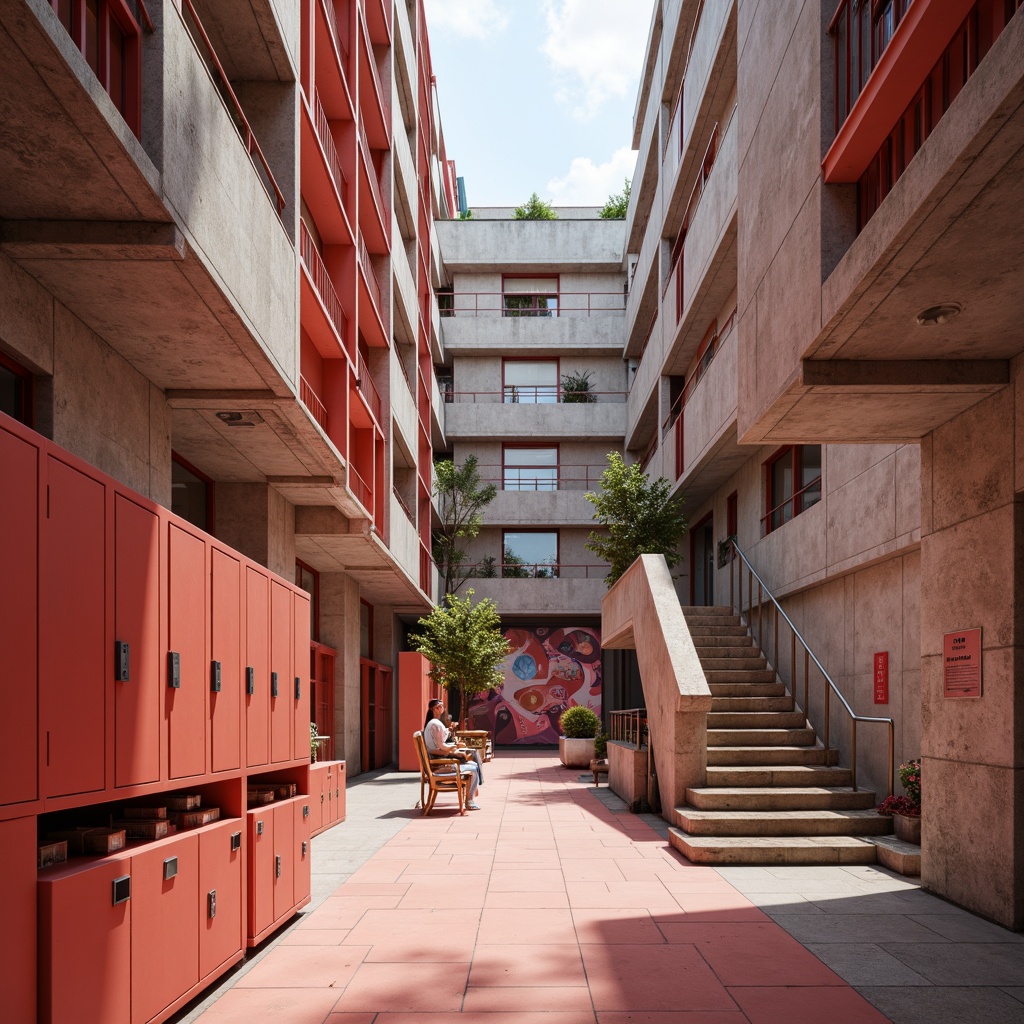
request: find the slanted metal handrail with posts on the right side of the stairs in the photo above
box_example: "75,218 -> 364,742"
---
729,538 -> 895,797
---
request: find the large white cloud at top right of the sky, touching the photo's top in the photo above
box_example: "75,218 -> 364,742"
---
541,0 -> 651,121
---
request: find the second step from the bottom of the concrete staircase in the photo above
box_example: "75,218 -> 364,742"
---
673,807 -> 892,838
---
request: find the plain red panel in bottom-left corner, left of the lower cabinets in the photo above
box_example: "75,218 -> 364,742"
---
0,817 -> 36,1022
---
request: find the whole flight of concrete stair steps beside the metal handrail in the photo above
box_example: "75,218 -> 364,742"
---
670,607 -> 893,864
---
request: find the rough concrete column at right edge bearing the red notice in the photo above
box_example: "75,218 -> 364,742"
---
921,368 -> 1024,929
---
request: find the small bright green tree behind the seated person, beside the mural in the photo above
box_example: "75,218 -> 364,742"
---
409,589 -> 511,716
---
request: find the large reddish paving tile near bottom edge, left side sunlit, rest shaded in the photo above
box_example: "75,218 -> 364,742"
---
581,945 -> 735,1013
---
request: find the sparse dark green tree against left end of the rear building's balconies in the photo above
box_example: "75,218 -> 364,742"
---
433,455 -> 498,594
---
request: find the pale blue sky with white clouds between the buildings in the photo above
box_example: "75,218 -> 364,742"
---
425,0 -> 653,209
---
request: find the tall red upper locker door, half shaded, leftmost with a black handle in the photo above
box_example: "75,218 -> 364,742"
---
111,495 -> 161,785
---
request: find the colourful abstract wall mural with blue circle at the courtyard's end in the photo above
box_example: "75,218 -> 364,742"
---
468,626 -> 601,745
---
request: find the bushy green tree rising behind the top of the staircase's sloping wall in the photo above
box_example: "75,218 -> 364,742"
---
584,452 -> 686,587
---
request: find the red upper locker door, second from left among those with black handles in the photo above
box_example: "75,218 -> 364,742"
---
164,523 -> 210,778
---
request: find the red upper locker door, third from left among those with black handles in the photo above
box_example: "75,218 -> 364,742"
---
210,548 -> 245,771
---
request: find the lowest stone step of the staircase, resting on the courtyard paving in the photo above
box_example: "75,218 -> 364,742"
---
669,827 -> 877,864
